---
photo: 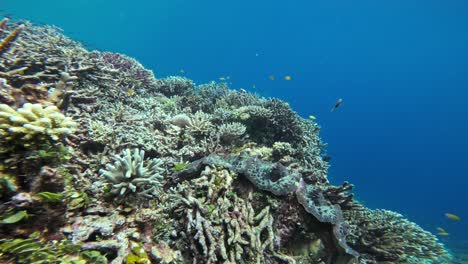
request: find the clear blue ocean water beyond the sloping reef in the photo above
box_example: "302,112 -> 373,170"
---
4,0 -> 468,253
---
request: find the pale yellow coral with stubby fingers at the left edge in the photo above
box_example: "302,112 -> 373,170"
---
0,103 -> 76,145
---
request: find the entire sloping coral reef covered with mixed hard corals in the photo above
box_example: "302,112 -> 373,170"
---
0,20 -> 451,264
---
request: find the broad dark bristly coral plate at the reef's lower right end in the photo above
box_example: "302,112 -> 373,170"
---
344,206 -> 451,264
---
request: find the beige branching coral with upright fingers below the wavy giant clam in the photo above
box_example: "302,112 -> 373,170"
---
176,167 -> 275,263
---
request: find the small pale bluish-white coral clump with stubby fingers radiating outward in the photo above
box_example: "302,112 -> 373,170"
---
99,149 -> 164,198
